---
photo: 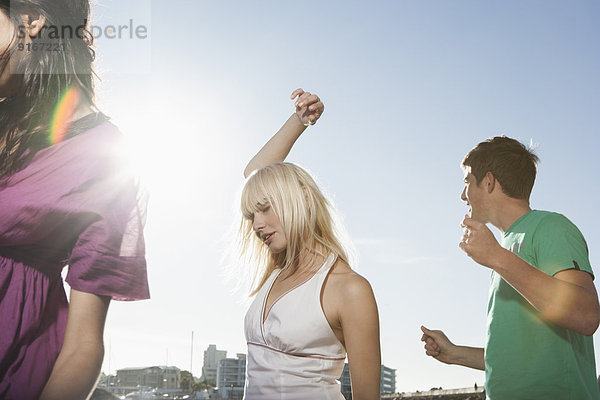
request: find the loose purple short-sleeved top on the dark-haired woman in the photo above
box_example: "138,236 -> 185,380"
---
0,122 -> 150,400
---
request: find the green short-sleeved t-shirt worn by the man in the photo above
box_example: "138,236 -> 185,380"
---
485,210 -> 600,400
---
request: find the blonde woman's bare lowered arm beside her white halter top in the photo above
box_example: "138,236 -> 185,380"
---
340,275 -> 381,400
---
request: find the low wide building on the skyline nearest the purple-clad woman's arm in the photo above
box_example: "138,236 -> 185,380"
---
116,366 -> 181,390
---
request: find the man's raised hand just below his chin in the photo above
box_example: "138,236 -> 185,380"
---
458,215 -> 504,268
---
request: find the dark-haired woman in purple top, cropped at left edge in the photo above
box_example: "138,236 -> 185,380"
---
0,0 -> 149,400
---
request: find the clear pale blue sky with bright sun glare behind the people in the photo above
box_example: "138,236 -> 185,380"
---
83,0 -> 600,391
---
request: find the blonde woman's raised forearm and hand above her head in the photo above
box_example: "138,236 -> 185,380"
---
244,89 -> 325,178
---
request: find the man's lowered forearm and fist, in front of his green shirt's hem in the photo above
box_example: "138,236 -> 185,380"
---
421,326 -> 485,371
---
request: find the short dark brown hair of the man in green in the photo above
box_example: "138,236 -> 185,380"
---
462,135 -> 539,201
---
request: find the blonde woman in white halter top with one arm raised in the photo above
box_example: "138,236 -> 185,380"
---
241,89 -> 381,400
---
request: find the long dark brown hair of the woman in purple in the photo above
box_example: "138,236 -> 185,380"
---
0,0 -> 95,178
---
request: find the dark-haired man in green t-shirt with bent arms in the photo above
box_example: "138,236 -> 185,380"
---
421,136 -> 600,400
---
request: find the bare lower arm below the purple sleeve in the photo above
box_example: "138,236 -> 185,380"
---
40,289 -> 110,400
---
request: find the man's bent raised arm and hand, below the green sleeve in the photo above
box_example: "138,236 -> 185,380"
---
460,217 -> 600,336
